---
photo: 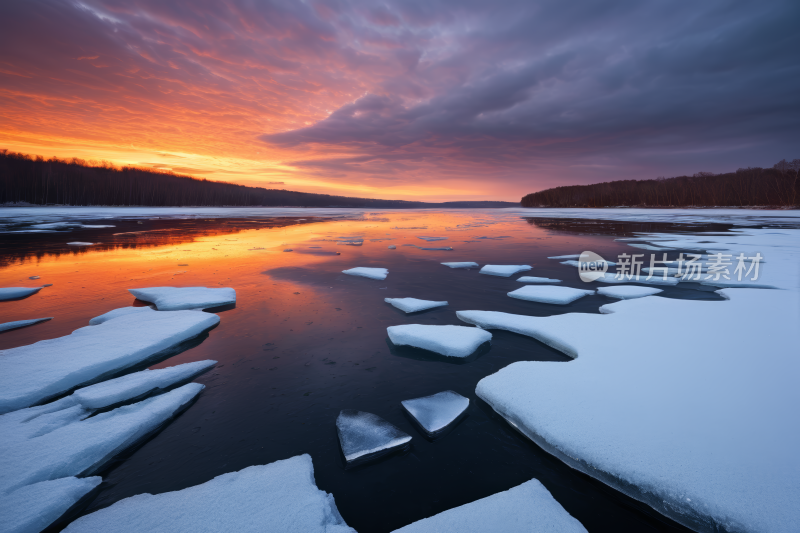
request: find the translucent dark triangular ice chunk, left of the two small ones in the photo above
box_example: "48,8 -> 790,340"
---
336,409 -> 411,463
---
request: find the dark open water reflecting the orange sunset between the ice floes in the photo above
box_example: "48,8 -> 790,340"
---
0,211 -> 727,533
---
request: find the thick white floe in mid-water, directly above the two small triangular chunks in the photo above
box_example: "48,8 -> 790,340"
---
386,324 -> 492,357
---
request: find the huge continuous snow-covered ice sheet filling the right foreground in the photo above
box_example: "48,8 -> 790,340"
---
472,229 -> 800,532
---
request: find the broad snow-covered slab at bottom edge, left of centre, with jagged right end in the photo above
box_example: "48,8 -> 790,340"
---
59,455 -> 355,533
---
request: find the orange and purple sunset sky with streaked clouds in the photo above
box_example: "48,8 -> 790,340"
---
0,0 -> 800,201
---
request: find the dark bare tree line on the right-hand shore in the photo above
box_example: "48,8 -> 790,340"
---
522,159 -> 800,207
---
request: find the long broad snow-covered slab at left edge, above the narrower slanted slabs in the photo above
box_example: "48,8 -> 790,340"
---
0,310 -> 219,414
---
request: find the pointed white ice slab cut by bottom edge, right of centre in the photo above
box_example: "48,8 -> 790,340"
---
394,479 -> 586,533
